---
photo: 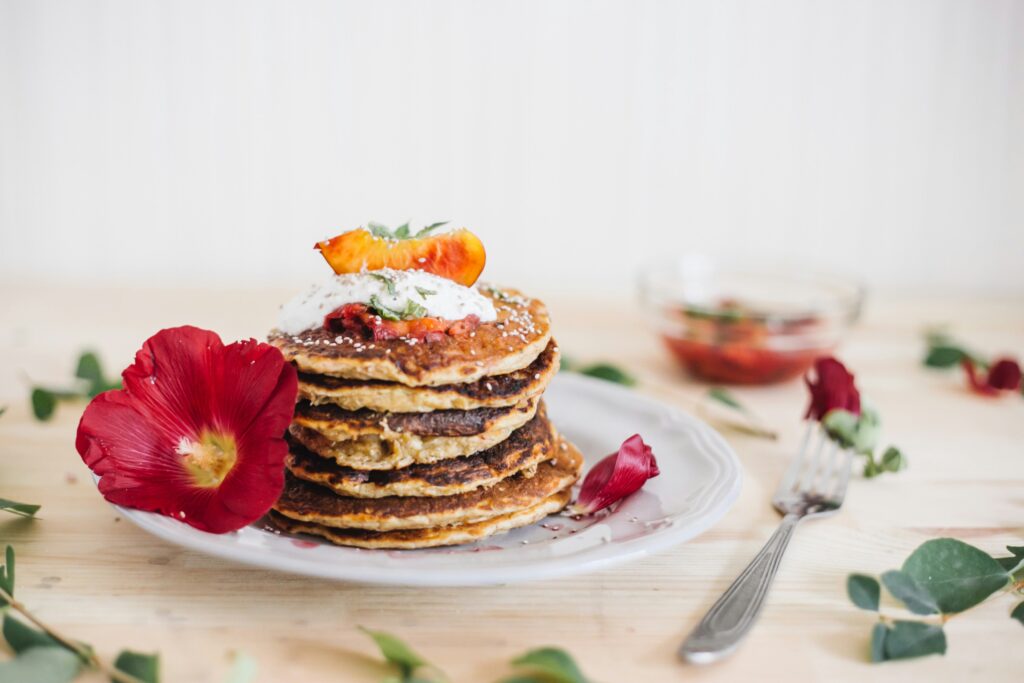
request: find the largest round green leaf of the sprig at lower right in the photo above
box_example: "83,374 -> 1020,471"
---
905,539 -> 1010,614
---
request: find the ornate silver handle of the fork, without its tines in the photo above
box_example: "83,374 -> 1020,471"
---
679,514 -> 802,664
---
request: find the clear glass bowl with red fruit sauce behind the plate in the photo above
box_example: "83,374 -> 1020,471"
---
640,255 -> 864,384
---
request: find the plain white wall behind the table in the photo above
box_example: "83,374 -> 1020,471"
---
0,0 -> 1024,294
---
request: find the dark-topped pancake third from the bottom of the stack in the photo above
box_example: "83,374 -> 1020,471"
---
286,405 -> 556,498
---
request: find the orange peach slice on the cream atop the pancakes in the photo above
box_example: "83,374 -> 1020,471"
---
315,227 -> 487,287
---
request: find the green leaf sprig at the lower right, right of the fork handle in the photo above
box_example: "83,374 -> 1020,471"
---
846,539 -> 1024,661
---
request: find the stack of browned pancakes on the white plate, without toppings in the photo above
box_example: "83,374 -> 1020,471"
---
269,288 -> 583,548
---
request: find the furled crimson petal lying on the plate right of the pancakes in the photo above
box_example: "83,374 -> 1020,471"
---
569,434 -> 659,515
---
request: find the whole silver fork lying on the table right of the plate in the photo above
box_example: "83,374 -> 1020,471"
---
679,422 -> 853,664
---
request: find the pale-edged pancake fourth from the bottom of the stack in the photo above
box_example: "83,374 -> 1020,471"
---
289,399 -> 540,470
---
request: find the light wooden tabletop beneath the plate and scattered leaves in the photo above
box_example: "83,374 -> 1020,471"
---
0,284 -> 1024,683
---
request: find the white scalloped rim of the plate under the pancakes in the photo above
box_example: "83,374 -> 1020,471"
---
105,373 -> 742,587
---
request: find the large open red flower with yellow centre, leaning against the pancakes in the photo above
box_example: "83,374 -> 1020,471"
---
75,327 -> 298,533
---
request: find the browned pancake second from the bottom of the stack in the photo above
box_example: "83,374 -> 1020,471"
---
273,439 -> 583,531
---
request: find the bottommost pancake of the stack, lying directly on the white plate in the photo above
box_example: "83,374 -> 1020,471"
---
268,488 -> 571,550
